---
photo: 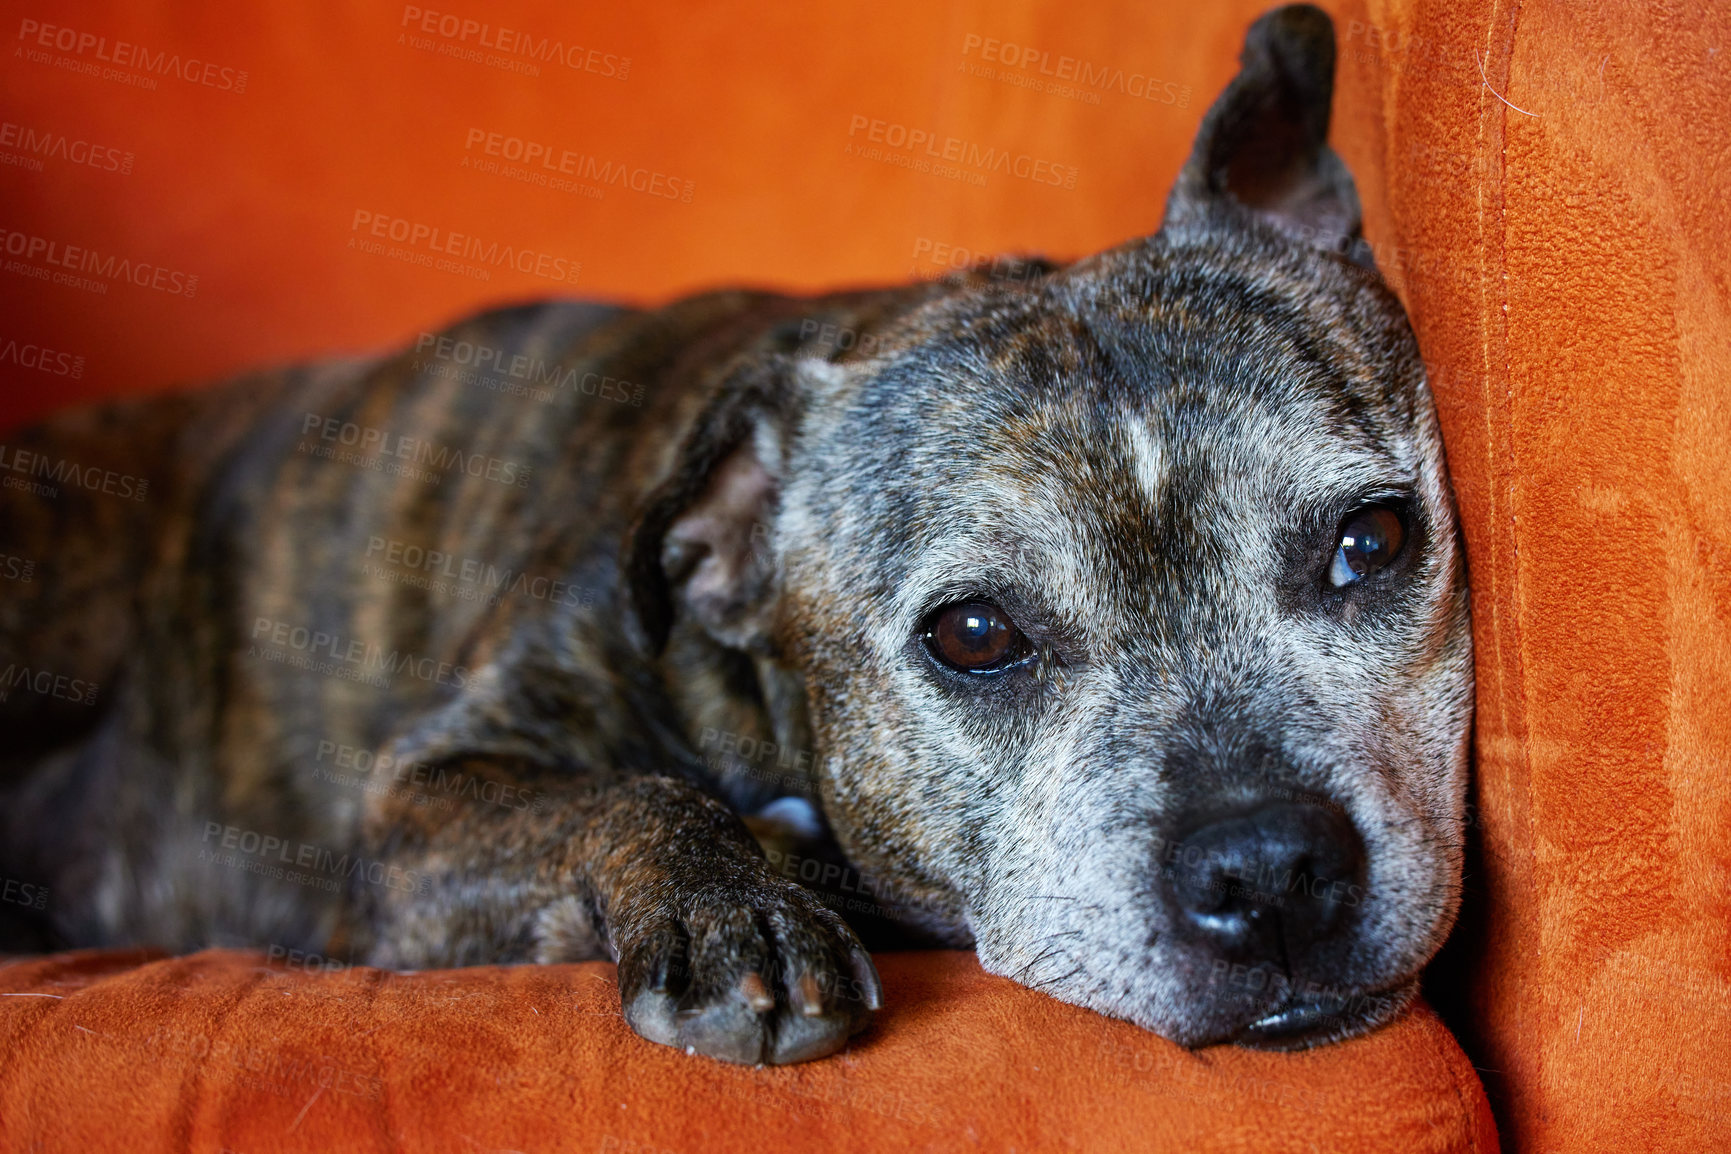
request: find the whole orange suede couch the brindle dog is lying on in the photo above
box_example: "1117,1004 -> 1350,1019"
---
0,0 -> 1731,1154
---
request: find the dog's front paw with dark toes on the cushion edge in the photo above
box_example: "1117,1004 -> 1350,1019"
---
615,874 -> 883,1066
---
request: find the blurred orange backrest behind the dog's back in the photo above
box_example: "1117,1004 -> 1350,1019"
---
0,0 -> 1262,429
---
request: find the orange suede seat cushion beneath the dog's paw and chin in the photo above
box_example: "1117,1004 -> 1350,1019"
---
0,950 -> 1496,1154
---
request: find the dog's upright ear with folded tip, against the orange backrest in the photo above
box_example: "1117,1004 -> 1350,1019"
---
1165,3 -> 1361,251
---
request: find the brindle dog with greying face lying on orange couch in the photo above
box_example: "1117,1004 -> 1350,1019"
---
0,5 -> 1471,1064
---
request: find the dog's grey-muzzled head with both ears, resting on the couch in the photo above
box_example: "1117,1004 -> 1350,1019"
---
639,7 -> 1471,1045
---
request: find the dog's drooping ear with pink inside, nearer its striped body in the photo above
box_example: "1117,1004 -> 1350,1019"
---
625,356 -> 798,652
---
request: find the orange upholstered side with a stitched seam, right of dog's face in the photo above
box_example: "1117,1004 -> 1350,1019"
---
1338,0 -> 1731,1151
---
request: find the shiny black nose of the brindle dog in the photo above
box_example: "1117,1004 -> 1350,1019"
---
1163,803 -> 1364,967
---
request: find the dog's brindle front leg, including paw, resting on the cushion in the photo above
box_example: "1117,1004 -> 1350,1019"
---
355,761 -> 881,1064
